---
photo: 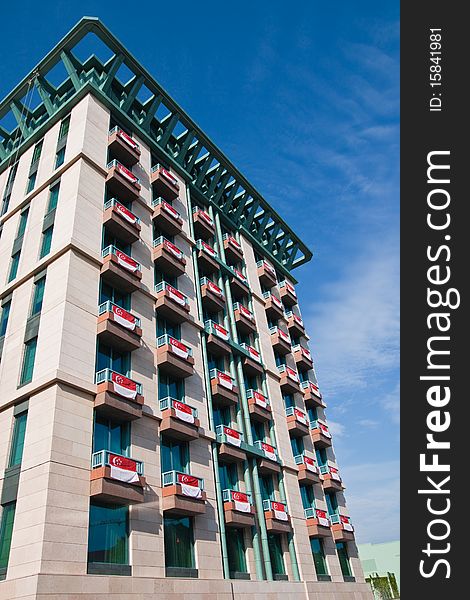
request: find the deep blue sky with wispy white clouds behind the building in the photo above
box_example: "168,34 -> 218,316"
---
0,0 -> 399,542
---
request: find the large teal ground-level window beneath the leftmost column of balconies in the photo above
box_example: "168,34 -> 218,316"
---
88,504 -> 129,565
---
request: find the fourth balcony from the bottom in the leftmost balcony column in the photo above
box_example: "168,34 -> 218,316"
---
101,246 -> 142,293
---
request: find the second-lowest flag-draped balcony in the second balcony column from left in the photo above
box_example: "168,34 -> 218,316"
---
160,396 -> 200,442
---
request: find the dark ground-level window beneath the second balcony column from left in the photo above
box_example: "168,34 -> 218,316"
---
163,516 -> 194,575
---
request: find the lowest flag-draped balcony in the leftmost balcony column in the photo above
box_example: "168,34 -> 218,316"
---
90,450 -> 145,505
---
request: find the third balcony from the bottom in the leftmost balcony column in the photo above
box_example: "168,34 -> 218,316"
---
97,301 -> 142,352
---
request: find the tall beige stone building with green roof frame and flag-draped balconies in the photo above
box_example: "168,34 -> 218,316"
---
0,18 -> 371,600
